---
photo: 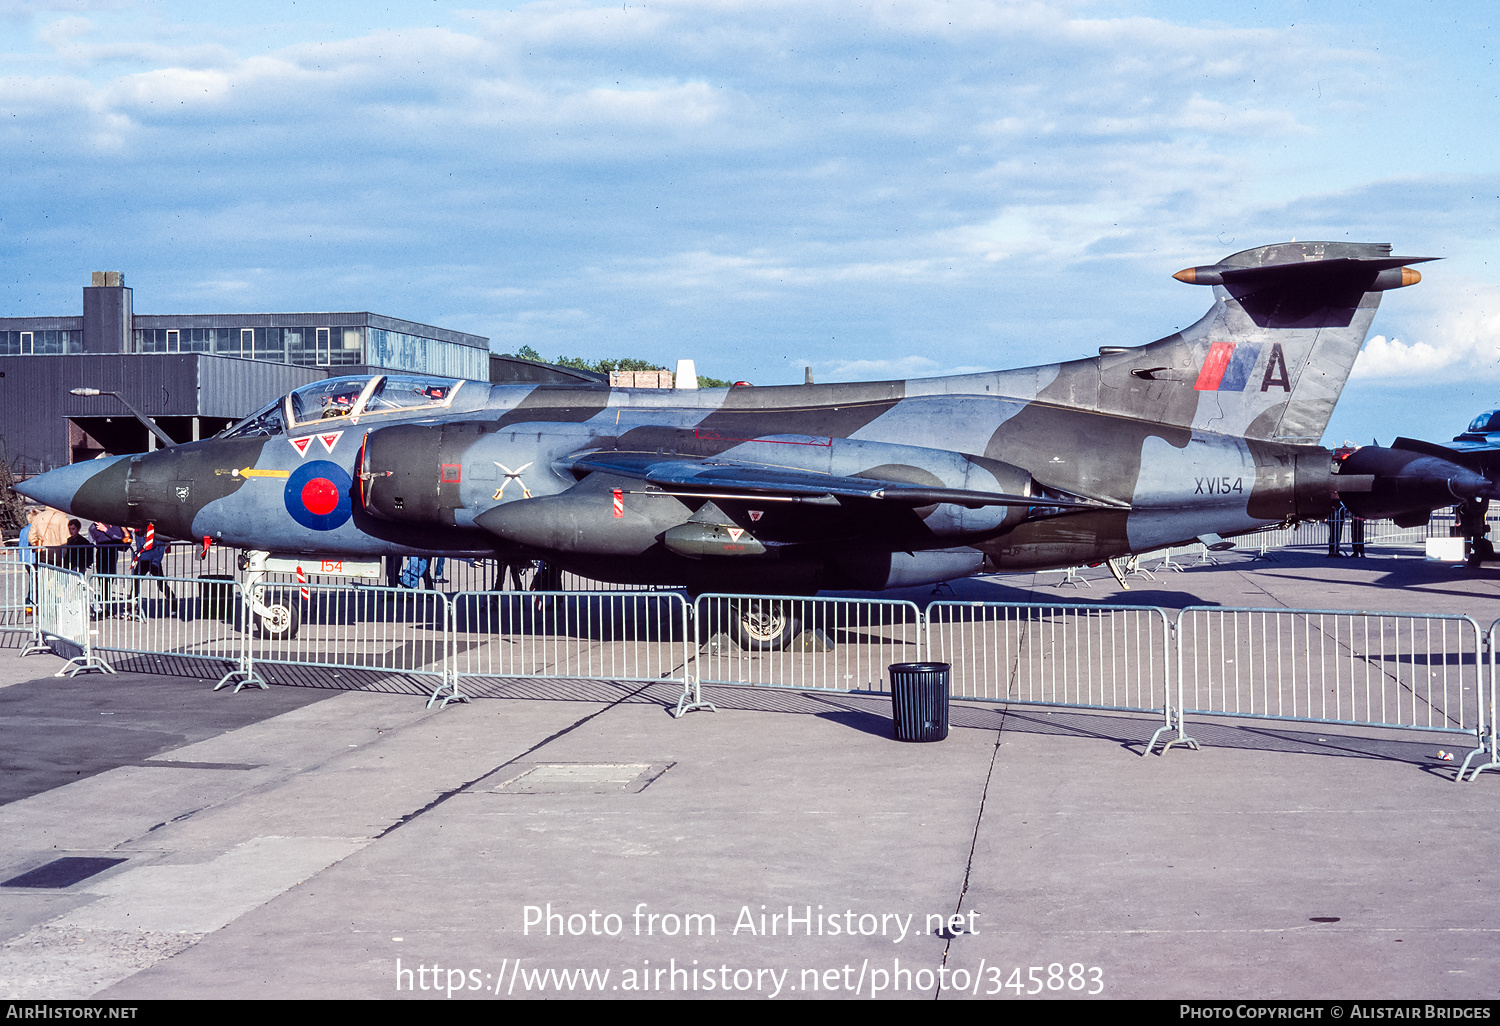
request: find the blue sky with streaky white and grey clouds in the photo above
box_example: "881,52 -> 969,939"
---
0,0 -> 1500,441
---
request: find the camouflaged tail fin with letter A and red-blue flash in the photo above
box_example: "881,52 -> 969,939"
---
1038,243 -> 1433,443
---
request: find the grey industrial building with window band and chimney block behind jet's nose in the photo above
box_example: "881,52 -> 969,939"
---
0,272 -> 492,477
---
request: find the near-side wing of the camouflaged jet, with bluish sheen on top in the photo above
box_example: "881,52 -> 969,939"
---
563,450 -> 1104,509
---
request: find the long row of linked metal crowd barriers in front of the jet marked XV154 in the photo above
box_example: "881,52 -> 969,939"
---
11,563 -> 1500,780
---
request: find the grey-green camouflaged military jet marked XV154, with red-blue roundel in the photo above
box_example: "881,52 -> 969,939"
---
20,242 -> 1490,645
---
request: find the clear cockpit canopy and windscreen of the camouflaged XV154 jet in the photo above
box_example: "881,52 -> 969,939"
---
219,374 -> 464,438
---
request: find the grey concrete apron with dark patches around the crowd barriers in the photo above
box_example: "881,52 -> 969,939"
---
0,551 -> 1500,1001
